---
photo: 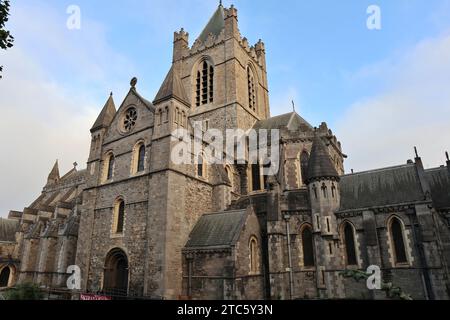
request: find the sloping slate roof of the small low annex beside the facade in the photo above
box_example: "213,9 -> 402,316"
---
186,209 -> 247,249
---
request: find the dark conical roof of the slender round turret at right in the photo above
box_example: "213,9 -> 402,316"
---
307,134 -> 339,181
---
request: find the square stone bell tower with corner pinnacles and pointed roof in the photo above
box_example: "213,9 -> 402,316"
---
171,3 -> 270,134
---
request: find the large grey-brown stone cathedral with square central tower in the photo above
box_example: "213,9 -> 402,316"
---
0,4 -> 450,300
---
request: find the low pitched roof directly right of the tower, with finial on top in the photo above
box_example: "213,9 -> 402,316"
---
253,112 -> 314,132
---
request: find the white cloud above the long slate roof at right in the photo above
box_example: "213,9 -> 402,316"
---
336,34 -> 450,171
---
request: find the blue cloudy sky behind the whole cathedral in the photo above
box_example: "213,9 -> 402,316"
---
0,0 -> 450,216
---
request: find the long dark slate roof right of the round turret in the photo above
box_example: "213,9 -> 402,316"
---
340,164 -> 425,211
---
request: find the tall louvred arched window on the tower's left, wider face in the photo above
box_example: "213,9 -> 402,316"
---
195,60 -> 214,107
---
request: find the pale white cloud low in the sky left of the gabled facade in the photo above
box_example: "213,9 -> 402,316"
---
0,48 -> 95,216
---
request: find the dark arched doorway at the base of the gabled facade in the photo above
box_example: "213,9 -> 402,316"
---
103,248 -> 128,297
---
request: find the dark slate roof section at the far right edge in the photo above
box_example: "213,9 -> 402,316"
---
425,167 -> 450,209
